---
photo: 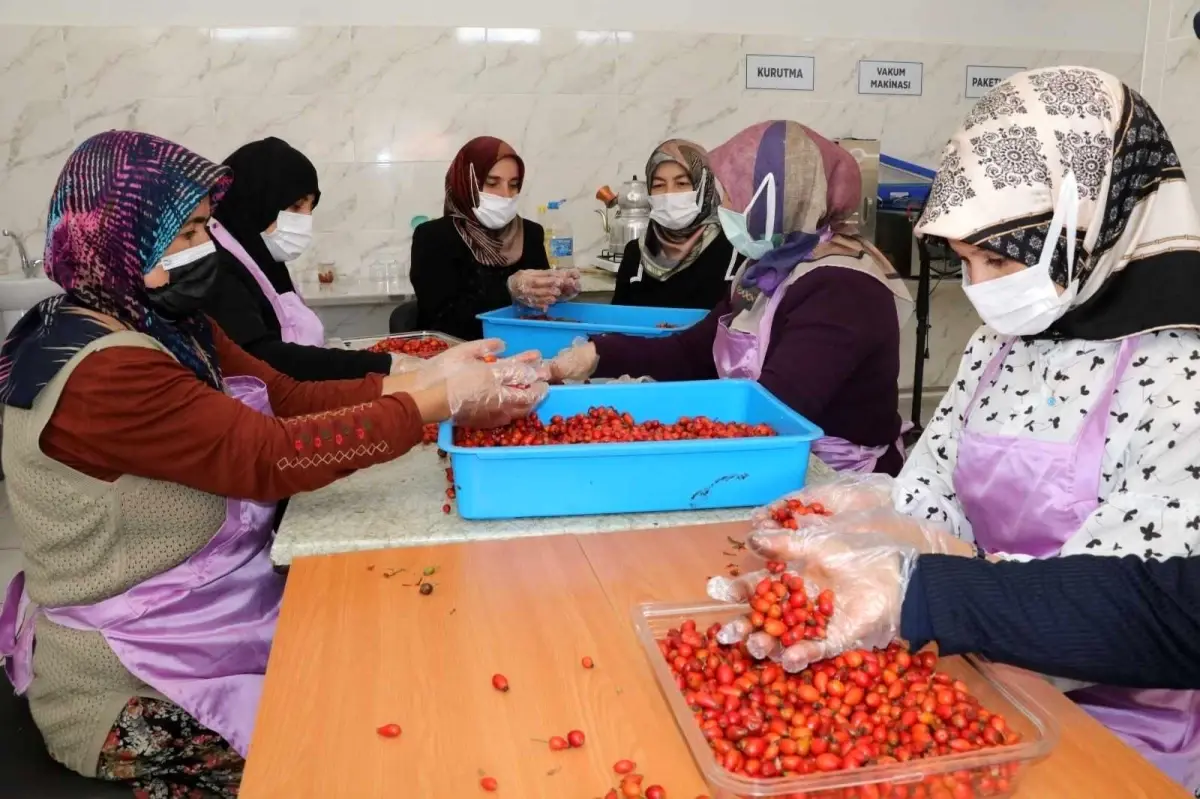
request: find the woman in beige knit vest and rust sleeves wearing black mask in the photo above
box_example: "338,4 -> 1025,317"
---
0,131 -> 545,797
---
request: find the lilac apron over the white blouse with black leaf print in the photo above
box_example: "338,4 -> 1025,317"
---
954,338 -> 1200,791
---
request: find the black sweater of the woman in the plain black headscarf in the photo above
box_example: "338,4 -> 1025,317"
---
204,253 -> 391,380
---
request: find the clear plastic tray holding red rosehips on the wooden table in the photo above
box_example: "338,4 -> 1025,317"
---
632,601 -> 1058,799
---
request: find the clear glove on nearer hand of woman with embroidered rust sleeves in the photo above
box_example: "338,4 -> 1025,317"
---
445,359 -> 550,427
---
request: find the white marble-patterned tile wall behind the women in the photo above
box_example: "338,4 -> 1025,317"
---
0,25 -> 1142,278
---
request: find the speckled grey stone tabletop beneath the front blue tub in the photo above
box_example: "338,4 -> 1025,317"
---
271,444 -> 828,565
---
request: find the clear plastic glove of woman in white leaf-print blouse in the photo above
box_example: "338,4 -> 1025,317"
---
746,506 -> 976,561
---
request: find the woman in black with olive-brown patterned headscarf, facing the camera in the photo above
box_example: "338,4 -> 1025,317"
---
612,139 -> 740,311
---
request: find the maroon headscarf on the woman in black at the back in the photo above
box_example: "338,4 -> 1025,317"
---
444,136 -> 524,266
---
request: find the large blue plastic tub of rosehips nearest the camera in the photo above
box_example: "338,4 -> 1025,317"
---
438,380 -> 822,519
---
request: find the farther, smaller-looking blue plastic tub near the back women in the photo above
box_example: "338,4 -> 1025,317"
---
478,302 -> 708,358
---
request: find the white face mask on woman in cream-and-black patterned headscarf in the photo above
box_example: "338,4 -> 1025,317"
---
962,173 -> 1079,336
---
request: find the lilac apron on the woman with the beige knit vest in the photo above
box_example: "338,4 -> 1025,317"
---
0,377 -> 284,757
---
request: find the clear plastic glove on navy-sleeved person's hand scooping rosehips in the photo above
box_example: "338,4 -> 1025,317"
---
708,534 -> 920,672
